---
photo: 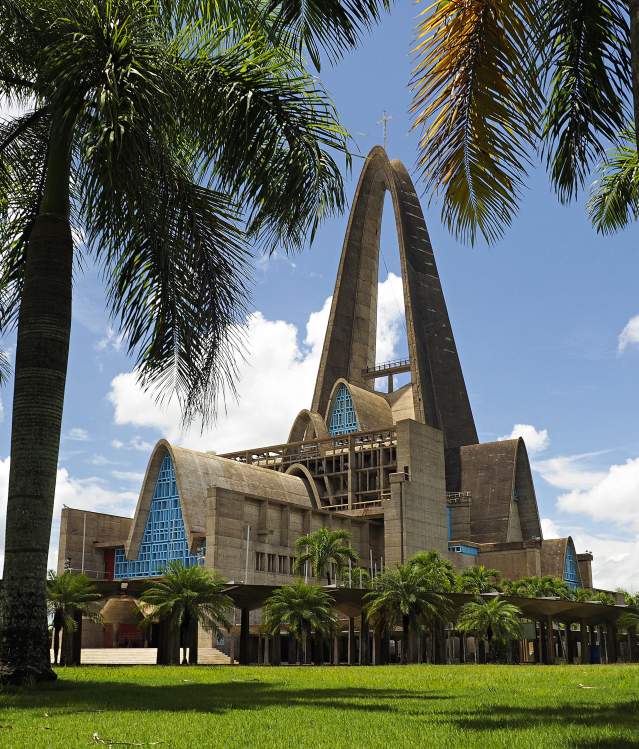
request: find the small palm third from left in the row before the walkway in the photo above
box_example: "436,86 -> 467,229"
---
264,580 -> 337,663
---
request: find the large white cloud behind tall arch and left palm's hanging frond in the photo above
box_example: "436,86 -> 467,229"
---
109,273 -> 404,452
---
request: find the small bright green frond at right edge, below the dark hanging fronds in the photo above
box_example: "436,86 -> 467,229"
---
587,130 -> 639,234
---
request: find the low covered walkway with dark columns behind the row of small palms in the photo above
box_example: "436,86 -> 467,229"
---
61,580 -> 639,665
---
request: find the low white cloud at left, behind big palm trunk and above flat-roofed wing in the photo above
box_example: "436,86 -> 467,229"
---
0,458 -> 137,569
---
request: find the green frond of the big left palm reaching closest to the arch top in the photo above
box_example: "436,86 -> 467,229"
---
180,33 -> 350,251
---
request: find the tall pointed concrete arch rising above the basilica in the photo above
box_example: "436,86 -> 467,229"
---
311,146 -> 478,448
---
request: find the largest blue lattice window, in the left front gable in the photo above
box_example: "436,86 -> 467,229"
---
113,455 -> 204,580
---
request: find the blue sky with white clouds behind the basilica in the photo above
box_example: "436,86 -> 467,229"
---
0,3 -> 639,589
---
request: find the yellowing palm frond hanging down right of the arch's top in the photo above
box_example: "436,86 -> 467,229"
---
412,0 -> 541,243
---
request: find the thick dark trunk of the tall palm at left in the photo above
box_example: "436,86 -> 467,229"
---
0,122 -> 73,683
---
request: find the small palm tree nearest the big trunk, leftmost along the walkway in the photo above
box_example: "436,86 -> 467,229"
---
47,570 -> 102,666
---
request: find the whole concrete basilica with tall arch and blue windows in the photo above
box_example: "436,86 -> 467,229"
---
59,147 -> 592,608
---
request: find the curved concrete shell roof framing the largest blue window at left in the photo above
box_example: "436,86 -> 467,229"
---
125,440 -> 313,559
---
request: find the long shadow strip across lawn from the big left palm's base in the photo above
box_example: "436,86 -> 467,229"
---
5,679 -> 451,717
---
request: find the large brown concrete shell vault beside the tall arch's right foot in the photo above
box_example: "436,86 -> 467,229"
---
449,438 -> 542,543
